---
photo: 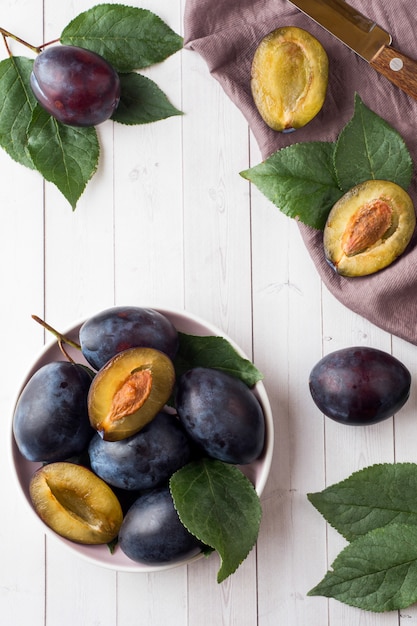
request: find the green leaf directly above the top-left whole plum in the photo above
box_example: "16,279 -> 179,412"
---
60,4 -> 183,72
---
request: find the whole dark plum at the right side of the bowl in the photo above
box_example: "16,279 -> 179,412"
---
176,367 -> 265,465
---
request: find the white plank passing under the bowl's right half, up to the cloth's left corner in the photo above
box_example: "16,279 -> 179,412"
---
183,29 -> 256,626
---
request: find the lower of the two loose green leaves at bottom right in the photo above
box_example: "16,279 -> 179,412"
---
308,524 -> 417,612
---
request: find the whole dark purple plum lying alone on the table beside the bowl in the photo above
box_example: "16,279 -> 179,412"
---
309,347 -> 411,426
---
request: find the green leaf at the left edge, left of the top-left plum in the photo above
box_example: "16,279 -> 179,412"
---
0,56 -> 36,169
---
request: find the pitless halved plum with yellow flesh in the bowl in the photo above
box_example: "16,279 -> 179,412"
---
29,461 -> 123,545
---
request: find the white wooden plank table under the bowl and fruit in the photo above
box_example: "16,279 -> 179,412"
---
0,0 -> 417,626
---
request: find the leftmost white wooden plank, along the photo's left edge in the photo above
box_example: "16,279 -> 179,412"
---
0,0 -> 45,626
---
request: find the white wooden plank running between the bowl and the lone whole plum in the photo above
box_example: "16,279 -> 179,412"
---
252,140 -> 327,626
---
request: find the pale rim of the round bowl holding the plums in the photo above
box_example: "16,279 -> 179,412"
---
7,305 -> 274,573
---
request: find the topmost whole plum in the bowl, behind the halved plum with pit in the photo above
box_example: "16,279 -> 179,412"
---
80,306 -> 178,370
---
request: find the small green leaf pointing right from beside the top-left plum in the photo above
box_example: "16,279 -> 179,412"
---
112,72 -> 182,124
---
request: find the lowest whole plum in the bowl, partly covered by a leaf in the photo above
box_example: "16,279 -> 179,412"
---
119,486 -> 201,564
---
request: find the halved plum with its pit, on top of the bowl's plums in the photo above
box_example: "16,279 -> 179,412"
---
88,348 -> 175,441
